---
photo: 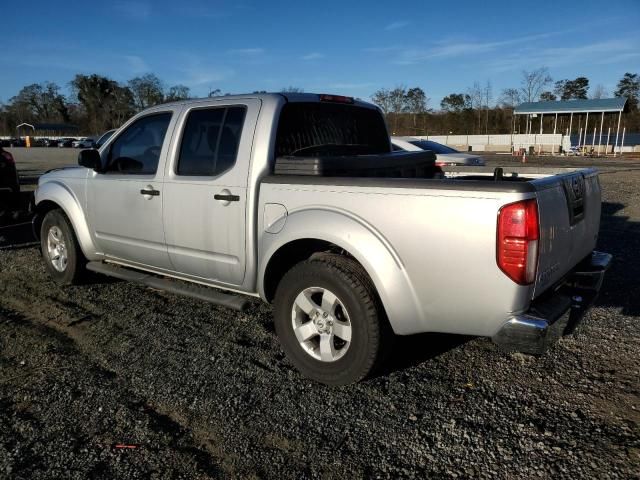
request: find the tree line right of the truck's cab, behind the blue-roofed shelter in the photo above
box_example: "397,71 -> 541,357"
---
371,67 -> 640,135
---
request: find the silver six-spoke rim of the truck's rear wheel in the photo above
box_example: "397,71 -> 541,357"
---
291,287 -> 352,362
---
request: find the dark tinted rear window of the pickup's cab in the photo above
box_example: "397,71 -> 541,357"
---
276,102 -> 391,157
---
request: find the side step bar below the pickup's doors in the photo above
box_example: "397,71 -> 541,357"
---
87,262 -> 251,312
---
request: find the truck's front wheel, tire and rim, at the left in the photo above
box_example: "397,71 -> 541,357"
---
40,209 -> 87,285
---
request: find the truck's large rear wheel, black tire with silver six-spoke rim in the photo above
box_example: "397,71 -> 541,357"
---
274,254 -> 393,385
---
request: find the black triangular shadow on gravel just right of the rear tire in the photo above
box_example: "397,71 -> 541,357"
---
376,333 -> 475,376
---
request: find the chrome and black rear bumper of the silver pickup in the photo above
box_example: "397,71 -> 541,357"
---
492,251 -> 612,355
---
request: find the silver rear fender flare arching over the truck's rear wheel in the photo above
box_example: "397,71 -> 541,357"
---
258,206 -> 425,335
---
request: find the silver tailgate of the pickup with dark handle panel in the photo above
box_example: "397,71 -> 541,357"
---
533,169 -> 601,297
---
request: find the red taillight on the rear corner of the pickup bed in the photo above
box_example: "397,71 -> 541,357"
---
497,200 -> 540,285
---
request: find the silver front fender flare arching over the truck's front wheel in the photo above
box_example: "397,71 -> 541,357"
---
34,180 -> 100,260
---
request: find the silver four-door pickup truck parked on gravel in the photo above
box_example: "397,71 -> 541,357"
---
34,94 -> 611,385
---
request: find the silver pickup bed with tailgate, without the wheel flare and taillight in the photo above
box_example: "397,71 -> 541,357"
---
260,167 -> 600,336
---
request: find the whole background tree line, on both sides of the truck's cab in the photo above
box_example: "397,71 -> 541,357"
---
0,67 -> 640,135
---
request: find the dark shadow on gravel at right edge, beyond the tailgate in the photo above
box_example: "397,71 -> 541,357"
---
596,202 -> 640,316
